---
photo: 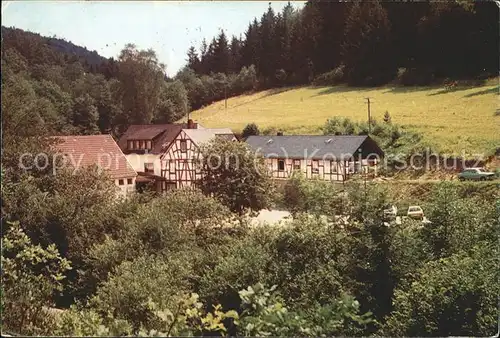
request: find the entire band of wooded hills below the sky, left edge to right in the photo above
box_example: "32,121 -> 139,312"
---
2,1 -> 499,135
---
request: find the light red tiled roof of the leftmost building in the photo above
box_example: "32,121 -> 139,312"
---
54,135 -> 137,179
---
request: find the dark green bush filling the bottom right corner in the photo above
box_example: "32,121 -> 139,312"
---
381,245 -> 500,337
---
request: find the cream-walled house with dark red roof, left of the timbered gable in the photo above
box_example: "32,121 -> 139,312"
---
118,120 -> 203,191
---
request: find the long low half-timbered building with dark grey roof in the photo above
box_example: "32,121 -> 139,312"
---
246,135 -> 384,181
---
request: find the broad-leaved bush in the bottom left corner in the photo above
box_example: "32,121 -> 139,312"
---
1,223 -> 71,335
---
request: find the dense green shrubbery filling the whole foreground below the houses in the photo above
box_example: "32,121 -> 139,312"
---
2,159 -> 498,336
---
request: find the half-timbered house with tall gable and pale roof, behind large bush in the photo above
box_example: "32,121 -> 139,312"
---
161,128 -> 236,190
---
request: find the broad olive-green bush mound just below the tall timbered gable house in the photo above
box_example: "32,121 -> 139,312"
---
85,189 -> 238,284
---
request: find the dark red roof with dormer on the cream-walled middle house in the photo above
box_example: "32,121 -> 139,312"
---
118,123 -> 199,154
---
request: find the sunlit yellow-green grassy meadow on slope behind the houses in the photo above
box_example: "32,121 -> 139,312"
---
191,79 -> 500,157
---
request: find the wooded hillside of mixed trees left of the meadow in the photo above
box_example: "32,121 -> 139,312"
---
2,27 -> 189,142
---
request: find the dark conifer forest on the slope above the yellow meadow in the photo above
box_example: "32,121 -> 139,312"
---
178,1 -> 499,108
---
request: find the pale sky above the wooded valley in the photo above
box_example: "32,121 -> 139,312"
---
2,1 -> 304,76
